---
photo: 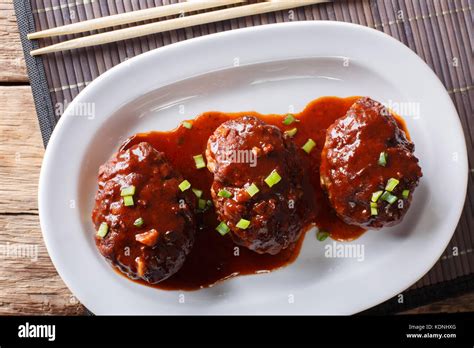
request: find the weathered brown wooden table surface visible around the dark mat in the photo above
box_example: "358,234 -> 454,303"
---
0,0 -> 474,315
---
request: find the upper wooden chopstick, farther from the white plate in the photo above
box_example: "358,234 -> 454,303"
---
27,0 -> 246,40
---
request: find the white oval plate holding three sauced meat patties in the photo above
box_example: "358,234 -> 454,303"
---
39,22 -> 467,314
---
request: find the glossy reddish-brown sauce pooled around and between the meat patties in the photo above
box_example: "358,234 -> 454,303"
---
117,97 -> 408,290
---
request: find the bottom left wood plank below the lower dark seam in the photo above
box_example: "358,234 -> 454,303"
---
0,214 -> 85,315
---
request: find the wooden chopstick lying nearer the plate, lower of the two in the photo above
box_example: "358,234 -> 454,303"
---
30,0 -> 330,56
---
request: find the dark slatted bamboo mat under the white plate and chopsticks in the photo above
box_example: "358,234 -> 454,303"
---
15,0 -> 474,313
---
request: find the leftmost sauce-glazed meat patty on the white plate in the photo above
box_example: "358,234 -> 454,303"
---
92,142 -> 196,284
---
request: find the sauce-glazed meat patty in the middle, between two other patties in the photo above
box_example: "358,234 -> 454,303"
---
206,116 -> 306,254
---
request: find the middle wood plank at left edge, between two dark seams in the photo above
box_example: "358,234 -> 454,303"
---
0,86 -> 44,213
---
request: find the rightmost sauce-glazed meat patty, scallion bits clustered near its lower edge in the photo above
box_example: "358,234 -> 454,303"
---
321,98 -> 422,228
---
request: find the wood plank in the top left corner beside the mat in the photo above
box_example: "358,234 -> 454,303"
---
0,0 -> 28,83
